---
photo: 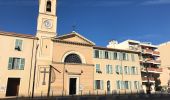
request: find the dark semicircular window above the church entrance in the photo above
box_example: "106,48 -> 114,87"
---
64,54 -> 82,63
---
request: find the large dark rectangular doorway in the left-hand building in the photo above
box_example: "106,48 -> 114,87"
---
6,78 -> 20,96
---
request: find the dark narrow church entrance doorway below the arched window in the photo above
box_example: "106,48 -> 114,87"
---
69,78 -> 77,95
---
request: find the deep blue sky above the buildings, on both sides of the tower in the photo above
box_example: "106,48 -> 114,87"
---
0,0 -> 170,46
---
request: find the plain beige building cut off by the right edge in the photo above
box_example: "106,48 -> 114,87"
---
158,42 -> 170,87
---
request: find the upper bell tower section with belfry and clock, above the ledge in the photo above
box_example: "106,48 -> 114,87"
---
36,0 -> 57,38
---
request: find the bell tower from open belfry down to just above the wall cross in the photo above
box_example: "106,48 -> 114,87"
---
36,0 -> 57,61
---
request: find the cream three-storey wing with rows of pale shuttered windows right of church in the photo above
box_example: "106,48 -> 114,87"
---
93,46 -> 143,94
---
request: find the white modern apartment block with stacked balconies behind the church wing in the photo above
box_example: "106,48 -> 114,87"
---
107,40 -> 162,92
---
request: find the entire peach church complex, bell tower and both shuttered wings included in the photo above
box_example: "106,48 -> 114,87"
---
0,0 -> 142,97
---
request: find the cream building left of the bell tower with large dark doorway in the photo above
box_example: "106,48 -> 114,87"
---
0,32 -> 37,98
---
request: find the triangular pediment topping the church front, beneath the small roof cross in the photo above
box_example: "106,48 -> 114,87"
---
56,32 -> 95,45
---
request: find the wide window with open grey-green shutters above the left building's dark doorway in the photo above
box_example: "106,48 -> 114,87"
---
8,57 -> 25,70
